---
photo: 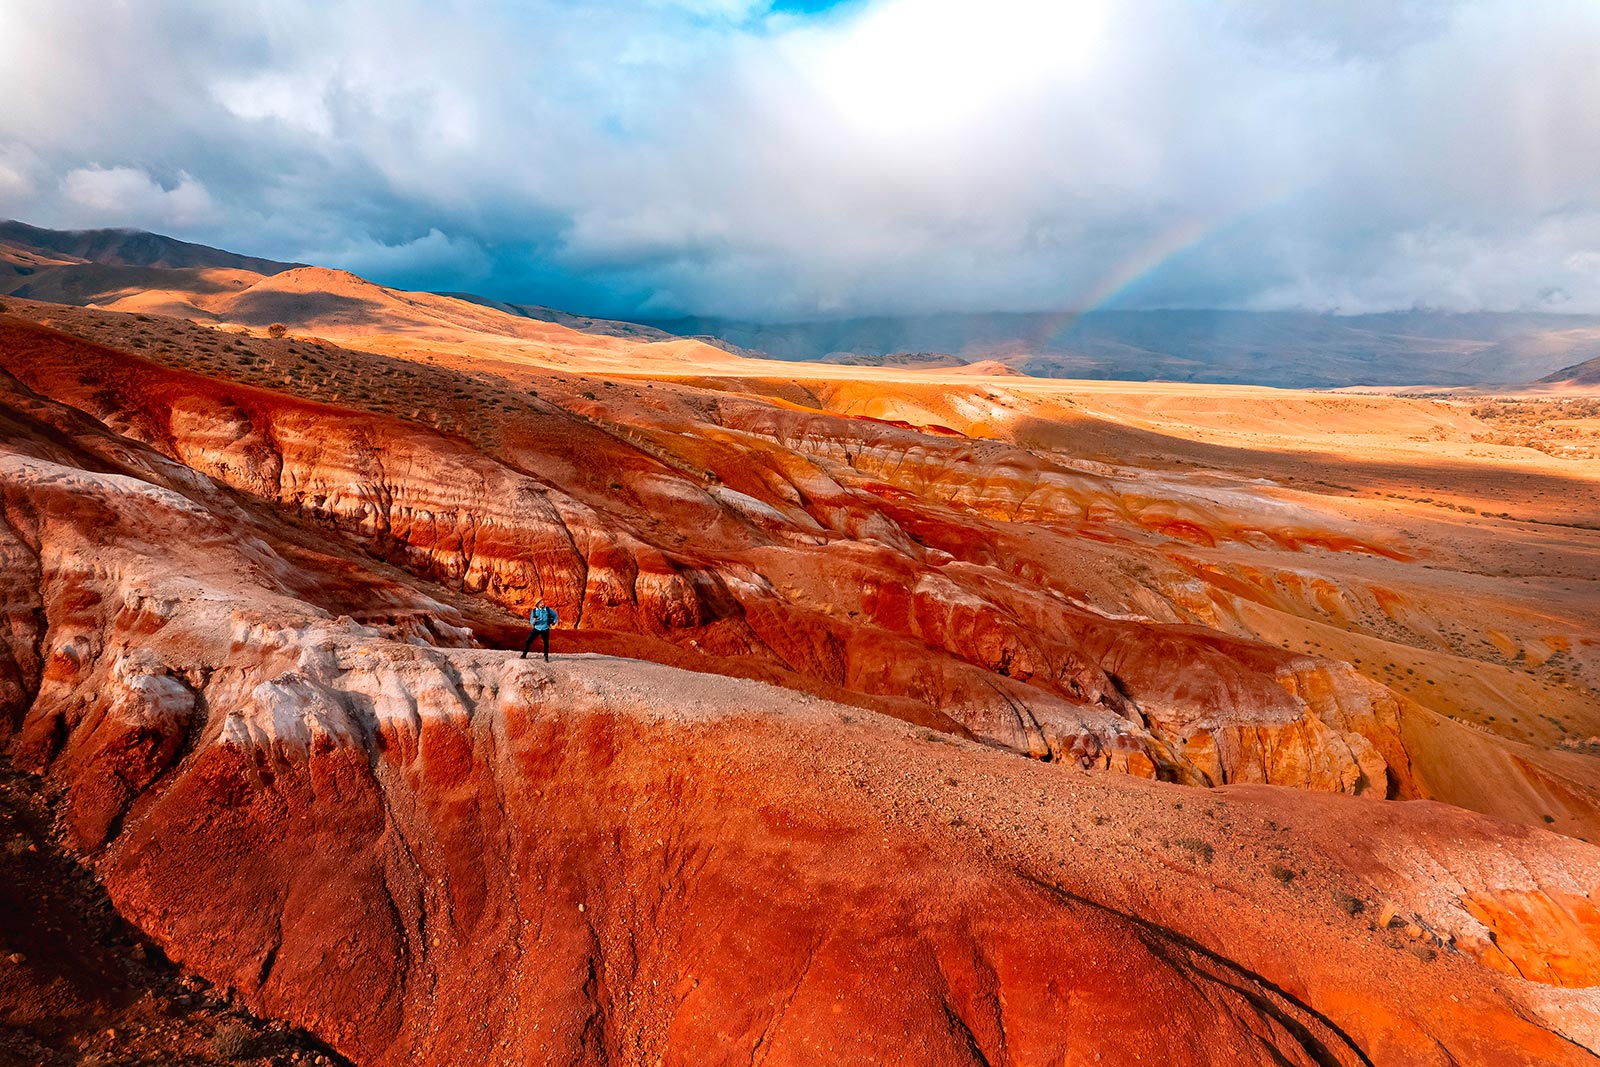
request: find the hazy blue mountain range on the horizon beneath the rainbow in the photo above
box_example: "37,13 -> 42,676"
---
646,310 -> 1600,387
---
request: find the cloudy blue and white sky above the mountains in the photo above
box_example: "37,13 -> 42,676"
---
0,0 -> 1600,322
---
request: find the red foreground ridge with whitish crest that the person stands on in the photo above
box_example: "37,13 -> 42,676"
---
3,396 -> 1600,1067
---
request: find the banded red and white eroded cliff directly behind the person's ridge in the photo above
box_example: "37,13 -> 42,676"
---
8,316 -> 1418,809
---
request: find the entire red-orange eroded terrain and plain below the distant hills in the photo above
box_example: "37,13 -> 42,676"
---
0,286 -> 1600,1064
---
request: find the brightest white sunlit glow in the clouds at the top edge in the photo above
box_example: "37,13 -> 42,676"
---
806,0 -> 1107,138
